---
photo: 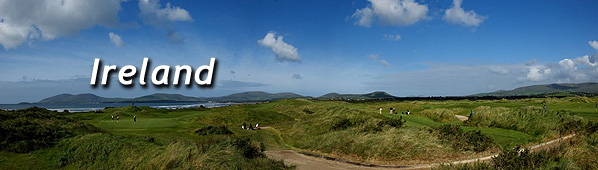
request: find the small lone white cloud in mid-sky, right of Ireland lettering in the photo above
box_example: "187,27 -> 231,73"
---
257,32 -> 301,62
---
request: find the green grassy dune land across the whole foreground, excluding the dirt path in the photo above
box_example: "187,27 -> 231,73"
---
0,97 -> 598,169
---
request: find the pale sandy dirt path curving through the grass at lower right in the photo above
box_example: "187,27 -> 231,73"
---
265,134 -> 575,170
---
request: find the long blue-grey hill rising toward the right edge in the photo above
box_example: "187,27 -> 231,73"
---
474,82 -> 598,96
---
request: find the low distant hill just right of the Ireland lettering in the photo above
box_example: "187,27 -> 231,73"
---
209,91 -> 305,102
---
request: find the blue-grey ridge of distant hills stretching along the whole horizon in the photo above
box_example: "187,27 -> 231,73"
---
37,82 -> 598,103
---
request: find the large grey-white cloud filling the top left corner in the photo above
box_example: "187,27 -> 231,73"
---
0,0 -> 121,49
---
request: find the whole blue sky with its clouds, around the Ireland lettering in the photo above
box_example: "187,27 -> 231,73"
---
0,0 -> 598,103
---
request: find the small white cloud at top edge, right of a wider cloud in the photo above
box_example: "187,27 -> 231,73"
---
443,0 -> 487,27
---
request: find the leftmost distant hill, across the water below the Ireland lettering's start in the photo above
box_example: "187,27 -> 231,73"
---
38,93 -> 124,103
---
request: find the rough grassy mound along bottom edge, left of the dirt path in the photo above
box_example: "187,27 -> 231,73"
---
56,134 -> 291,169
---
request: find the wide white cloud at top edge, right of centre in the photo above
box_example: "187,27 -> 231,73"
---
351,0 -> 428,27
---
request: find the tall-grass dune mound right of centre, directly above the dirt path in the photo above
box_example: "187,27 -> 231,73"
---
281,102 -> 474,163
